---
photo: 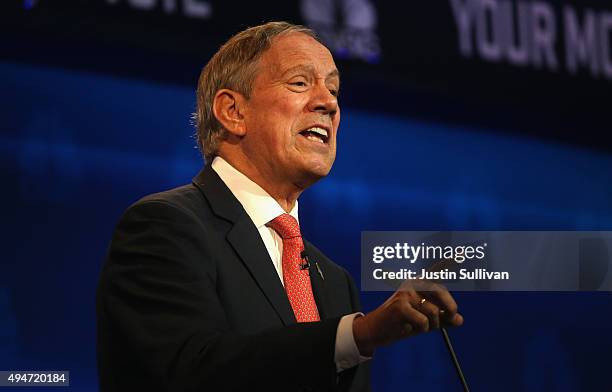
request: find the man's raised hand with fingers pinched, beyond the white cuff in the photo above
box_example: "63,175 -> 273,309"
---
353,280 -> 463,356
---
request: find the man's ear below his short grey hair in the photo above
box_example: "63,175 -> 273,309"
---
212,88 -> 246,137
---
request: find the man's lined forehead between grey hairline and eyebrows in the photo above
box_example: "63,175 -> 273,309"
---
260,33 -> 337,77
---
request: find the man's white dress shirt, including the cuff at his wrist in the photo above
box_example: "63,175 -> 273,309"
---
212,157 -> 370,372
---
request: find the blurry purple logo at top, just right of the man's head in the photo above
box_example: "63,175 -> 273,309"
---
300,0 -> 381,63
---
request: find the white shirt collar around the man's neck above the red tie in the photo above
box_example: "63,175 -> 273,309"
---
211,156 -> 299,229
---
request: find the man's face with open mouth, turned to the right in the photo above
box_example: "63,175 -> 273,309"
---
243,33 -> 340,188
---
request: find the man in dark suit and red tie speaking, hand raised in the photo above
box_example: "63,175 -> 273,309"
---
97,22 -> 462,391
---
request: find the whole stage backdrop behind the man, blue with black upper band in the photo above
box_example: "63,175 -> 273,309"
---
0,0 -> 612,391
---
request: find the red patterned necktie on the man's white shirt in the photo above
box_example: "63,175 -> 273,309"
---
267,214 -> 320,323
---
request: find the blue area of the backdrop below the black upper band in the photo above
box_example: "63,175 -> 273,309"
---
0,62 -> 612,391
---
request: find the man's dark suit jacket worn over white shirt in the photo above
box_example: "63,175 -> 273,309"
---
97,166 -> 369,392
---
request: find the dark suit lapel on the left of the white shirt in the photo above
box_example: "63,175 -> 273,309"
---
193,165 -> 296,325
